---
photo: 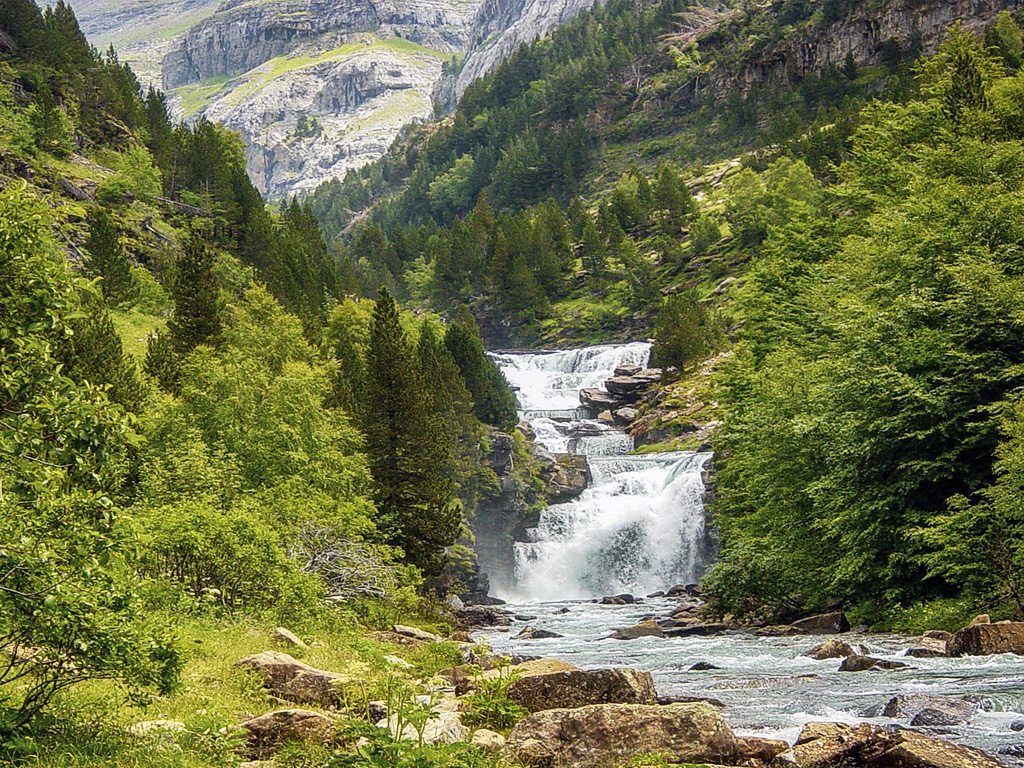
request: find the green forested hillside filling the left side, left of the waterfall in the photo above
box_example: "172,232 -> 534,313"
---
0,0 -> 515,766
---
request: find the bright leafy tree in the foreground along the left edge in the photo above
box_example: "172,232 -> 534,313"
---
0,186 -> 181,726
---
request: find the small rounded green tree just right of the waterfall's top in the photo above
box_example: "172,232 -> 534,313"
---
651,291 -> 723,371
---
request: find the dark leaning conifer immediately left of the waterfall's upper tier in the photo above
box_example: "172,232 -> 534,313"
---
444,305 -> 518,429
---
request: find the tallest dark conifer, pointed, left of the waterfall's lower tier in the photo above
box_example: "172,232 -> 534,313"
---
362,288 -> 462,578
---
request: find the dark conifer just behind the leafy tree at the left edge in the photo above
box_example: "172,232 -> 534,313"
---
65,297 -> 145,414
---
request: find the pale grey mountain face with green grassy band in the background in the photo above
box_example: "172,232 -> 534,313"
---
156,0 -> 479,198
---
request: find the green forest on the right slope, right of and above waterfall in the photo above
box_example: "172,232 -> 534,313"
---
310,2 -> 1022,626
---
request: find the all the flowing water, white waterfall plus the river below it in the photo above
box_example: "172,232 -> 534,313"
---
487,343 -> 1024,767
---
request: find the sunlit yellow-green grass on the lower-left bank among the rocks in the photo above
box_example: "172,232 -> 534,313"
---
12,612 -> 468,768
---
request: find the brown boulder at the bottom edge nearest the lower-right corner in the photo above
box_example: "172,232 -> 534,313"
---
771,723 -> 1000,768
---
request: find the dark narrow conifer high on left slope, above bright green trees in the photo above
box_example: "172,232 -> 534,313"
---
167,233 -> 221,354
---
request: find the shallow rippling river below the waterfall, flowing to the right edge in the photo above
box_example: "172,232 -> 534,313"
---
479,599 -> 1024,766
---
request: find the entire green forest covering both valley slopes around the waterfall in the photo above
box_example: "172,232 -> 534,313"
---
6,0 -> 1024,768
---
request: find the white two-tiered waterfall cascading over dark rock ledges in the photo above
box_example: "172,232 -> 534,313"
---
492,342 -> 711,601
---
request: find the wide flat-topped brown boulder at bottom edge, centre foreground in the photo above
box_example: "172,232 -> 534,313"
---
503,705 -> 738,768
